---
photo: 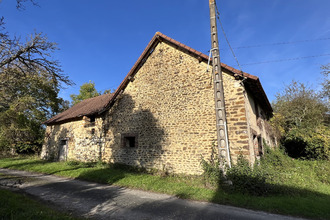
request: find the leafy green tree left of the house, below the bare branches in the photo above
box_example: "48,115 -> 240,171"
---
0,69 -> 70,152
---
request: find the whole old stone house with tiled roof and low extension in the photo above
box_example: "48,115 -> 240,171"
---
41,32 -> 273,174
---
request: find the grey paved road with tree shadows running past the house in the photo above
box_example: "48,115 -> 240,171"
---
0,168 -> 308,220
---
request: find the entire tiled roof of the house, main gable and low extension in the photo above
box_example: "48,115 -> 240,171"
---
44,32 -> 273,124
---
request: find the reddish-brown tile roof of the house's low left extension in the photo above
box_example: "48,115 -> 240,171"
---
44,94 -> 113,124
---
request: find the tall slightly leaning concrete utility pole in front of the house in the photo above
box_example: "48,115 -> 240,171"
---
209,0 -> 231,169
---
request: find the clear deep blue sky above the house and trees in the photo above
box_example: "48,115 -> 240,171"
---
0,0 -> 330,101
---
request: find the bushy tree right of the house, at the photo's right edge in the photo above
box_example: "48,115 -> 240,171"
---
272,81 -> 330,159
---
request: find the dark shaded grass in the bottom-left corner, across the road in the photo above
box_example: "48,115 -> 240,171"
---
0,189 -> 76,220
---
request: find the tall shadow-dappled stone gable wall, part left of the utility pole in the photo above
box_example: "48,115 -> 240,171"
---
105,43 -> 216,174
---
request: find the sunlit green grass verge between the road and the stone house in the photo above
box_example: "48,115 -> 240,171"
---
0,154 -> 330,219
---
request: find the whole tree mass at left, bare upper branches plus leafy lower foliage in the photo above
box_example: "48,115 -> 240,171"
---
0,0 -> 73,155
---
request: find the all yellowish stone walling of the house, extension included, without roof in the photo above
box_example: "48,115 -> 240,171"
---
42,40 -> 268,174
